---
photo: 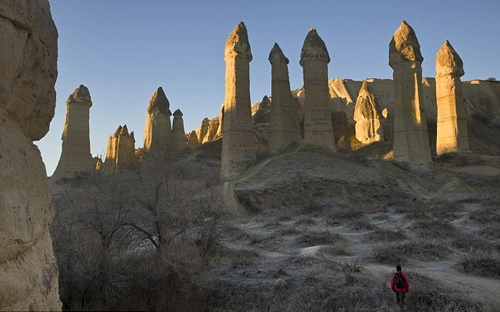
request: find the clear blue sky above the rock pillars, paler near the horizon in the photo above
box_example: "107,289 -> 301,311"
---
35,0 -> 500,176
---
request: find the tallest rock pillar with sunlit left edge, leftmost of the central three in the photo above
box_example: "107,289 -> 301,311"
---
221,22 -> 256,180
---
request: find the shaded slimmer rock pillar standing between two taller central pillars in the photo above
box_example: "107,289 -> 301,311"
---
268,43 -> 302,154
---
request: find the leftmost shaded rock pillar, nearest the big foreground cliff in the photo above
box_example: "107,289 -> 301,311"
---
52,85 -> 95,180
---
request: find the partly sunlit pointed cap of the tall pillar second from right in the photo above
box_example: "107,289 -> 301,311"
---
389,21 -> 424,67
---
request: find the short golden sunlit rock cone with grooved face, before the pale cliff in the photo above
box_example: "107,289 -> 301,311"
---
353,81 -> 384,144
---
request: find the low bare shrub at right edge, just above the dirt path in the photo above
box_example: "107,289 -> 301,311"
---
455,254 -> 500,277
